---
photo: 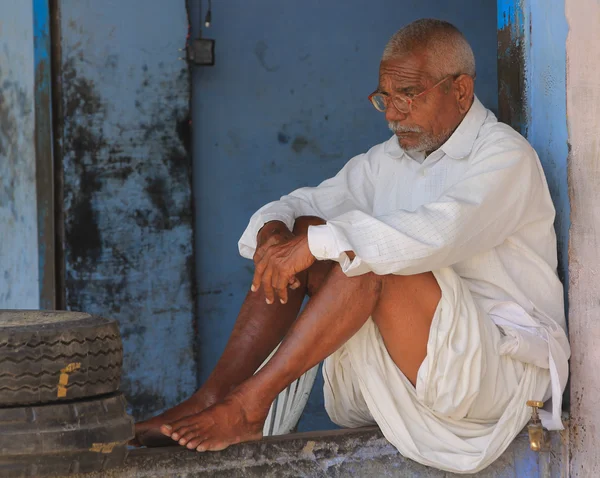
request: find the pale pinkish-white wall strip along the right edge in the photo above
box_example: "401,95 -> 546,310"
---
565,0 -> 600,478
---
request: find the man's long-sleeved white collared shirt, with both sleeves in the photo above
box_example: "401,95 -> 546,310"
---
239,98 -> 570,429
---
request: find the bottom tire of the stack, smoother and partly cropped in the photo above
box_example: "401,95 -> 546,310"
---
0,393 -> 134,478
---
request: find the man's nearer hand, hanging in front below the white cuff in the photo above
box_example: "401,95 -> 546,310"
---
252,235 -> 316,304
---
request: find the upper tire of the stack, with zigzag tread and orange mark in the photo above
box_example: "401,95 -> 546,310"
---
0,310 -> 123,407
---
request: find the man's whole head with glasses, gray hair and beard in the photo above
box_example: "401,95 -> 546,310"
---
371,19 -> 475,153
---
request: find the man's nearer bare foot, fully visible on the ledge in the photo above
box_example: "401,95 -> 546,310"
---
160,392 -> 271,451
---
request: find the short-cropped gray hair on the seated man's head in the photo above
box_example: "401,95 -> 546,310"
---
382,18 -> 475,79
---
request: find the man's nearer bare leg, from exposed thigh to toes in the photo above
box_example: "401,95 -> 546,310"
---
161,266 -> 441,451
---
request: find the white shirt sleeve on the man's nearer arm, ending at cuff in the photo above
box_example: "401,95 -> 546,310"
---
308,136 -> 552,275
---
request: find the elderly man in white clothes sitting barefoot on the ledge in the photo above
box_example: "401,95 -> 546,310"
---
138,20 -> 569,472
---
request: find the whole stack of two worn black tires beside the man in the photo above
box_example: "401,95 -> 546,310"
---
0,311 -> 134,478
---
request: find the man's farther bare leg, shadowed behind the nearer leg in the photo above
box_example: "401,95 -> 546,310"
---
132,217 -> 331,446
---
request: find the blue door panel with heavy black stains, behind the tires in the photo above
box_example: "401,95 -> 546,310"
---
57,0 -> 197,418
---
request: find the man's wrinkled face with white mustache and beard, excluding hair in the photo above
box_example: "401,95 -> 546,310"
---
378,52 -> 472,153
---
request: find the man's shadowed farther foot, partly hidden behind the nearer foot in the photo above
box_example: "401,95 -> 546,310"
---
129,389 -> 219,447
